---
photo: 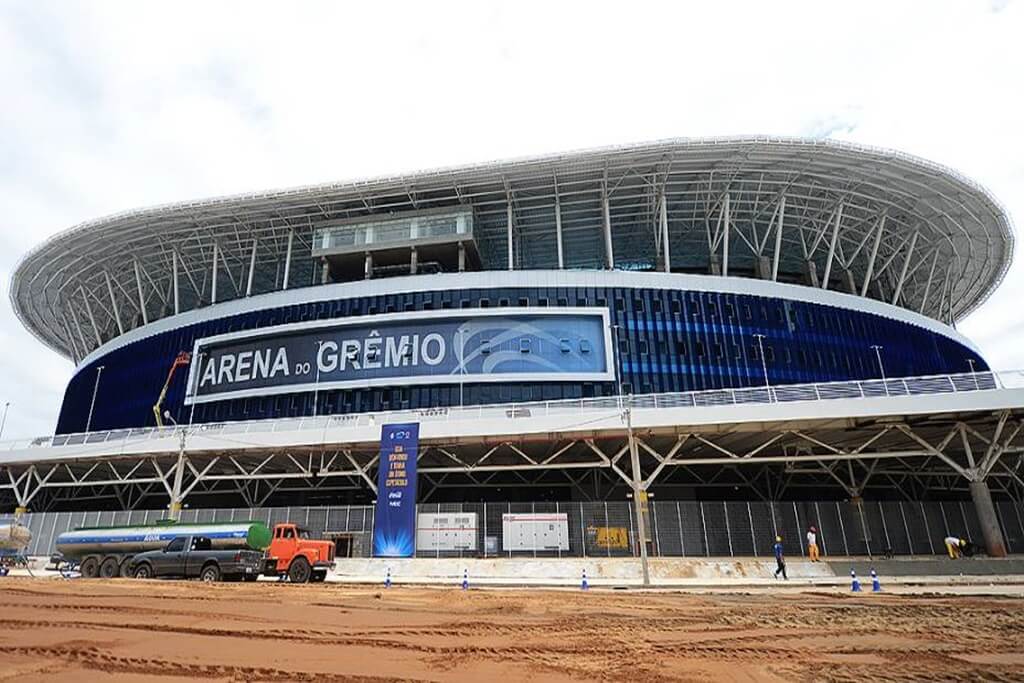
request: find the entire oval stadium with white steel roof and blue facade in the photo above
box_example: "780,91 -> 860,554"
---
0,138 -> 1024,555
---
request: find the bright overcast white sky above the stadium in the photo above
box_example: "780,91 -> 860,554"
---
0,0 -> 1024,438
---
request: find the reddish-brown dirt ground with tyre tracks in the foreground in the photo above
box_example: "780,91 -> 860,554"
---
0,579 -> 1024,683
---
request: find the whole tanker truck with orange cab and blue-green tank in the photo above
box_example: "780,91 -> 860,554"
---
54,520 -> 334,584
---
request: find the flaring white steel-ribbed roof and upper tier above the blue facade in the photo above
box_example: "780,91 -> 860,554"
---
10,138 -> 1013,361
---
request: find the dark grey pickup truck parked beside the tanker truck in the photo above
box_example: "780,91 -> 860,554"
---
128,536 -> 263,581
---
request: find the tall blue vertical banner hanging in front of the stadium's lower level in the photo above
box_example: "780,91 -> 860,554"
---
374,422 -> 420,557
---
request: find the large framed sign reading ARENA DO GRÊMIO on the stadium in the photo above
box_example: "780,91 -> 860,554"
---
185,307 -> 614,404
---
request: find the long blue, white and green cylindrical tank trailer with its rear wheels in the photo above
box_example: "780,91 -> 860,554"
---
54,521 -> 270,579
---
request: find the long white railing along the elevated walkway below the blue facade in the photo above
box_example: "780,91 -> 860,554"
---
0,371 -> 1024,452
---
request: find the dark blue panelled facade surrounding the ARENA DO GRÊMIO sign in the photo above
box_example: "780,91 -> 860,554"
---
57,287 -> 987,433
